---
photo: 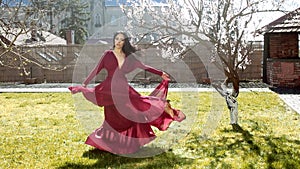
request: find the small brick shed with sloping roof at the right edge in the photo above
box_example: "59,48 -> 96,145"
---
261,8 -> 300,88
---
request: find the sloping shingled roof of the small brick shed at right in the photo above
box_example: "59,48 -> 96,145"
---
260,8 -> 300,33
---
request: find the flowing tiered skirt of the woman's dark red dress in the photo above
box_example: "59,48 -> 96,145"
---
69,81 -> 185,154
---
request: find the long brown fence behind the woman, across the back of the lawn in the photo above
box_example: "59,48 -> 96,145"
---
0,45 -> 263,83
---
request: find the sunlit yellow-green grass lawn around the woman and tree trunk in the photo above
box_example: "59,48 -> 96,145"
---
0,92 -> 300,169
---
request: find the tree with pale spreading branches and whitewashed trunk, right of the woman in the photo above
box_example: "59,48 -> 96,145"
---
122,0 -> 296,127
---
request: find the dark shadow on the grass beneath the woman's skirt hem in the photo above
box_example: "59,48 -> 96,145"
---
59,148 -> 192,169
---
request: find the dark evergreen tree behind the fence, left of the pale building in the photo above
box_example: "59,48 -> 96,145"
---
30,0 -> 90,44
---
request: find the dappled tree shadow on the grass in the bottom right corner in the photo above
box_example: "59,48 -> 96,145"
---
210,124 -> 300,169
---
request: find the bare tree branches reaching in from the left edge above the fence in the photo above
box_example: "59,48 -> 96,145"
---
0,0 -> 66,76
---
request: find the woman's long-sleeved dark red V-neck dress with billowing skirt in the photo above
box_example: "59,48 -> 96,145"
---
69,50 -> 185,154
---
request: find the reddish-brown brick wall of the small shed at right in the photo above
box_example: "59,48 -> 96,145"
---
264,33 -> 300,88
